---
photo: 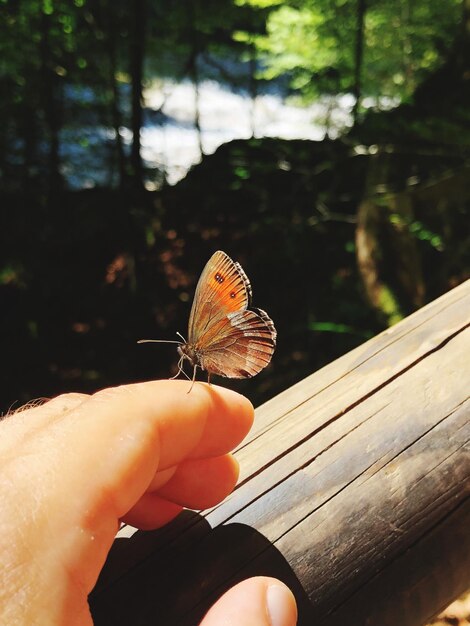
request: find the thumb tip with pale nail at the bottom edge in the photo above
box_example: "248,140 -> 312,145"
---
200,576 -> 297,626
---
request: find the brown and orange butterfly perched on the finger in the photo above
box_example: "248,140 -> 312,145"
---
138,250 -> 277,391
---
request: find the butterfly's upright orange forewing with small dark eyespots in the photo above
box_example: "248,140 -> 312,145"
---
188,250 -> 251,345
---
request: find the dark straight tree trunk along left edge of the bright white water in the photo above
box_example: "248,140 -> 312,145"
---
130,0 -> 145,188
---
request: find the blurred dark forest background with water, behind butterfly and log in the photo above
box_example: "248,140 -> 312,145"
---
0,0 -> 470,412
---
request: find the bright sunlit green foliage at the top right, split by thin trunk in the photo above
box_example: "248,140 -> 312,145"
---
239,0 -> 461,103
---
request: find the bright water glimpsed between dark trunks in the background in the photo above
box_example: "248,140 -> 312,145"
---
62,81 -> 353,189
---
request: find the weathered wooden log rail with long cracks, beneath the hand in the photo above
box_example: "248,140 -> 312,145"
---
91,281 -> 470,626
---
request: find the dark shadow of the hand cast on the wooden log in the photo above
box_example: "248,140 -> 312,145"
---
90,512 -> 311,626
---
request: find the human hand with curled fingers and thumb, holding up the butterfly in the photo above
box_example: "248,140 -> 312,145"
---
0,381 -> 296,626
